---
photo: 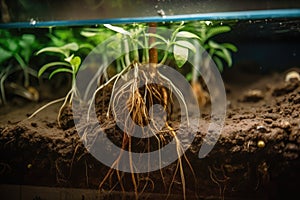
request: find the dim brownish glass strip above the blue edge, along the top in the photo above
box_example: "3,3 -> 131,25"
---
1,0 -> 300,25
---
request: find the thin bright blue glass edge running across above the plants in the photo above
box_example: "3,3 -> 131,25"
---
0,8 -> 300,29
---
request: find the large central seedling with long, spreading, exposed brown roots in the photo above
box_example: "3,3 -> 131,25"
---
79,23 -> 209,197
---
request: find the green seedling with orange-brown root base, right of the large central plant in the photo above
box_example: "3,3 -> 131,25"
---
179,21 -> 238,106
